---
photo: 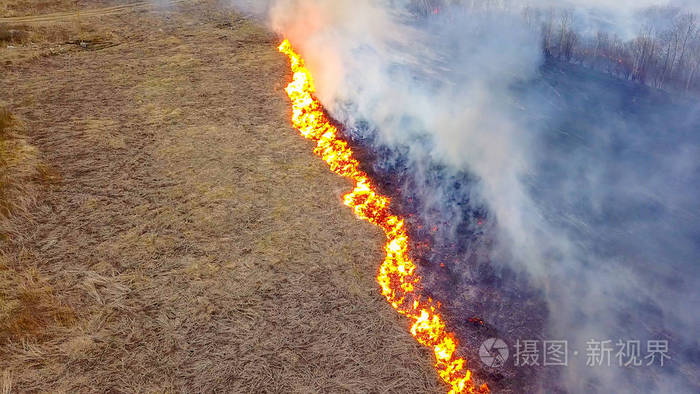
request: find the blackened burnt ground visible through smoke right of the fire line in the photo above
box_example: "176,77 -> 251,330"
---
340,56 -> 700,392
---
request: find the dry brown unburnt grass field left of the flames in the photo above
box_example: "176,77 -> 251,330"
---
0,0 -> 443,393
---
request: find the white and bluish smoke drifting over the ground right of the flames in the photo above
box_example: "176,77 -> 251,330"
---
227,0 -> 700,393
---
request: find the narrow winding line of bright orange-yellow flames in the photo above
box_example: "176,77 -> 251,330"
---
278,40 -> 489,393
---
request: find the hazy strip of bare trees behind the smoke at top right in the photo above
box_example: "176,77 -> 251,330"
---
409,0 -> 700,92
